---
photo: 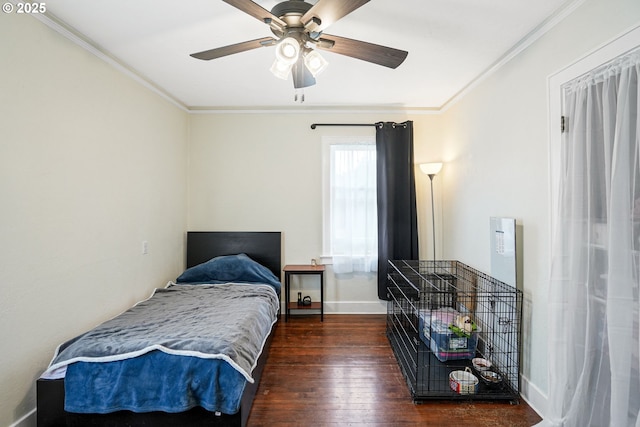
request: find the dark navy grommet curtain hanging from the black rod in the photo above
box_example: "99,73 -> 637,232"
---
376,121 -> 418,300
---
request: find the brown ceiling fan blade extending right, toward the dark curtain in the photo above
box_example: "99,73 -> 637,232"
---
316,34 -> 409,68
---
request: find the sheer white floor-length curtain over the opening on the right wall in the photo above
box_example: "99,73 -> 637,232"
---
544,50 -> 640,427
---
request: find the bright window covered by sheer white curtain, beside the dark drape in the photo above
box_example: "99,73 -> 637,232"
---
323,136 -> 378,274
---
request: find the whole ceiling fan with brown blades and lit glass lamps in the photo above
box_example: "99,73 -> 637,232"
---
191,0 -> 408,89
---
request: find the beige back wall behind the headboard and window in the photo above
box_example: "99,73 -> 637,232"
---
189,113 -> 440,313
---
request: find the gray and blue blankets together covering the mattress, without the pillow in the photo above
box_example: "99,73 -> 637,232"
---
45,284 -> 279,413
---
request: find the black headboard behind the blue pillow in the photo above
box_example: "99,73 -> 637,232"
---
187,231 -> 282,279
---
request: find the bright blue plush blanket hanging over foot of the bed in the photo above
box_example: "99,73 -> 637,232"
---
65,350 -> 247,414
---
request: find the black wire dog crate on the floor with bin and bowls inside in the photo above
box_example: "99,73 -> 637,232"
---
387,260 -> 522,403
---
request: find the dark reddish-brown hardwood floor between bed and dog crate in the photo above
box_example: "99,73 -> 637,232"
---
249,314 -> 540,427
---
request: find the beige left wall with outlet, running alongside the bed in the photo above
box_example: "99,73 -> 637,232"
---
0,13 -> 188,427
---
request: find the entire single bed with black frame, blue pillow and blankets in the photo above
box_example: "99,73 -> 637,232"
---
36,232 -> 282,427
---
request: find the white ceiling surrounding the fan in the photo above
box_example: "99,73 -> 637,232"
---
45,0 -> 576,109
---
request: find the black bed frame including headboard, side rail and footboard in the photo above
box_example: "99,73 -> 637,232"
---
36,231 -> 282,427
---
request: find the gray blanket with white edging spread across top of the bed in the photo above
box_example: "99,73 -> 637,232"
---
43,284 -> 279,382
